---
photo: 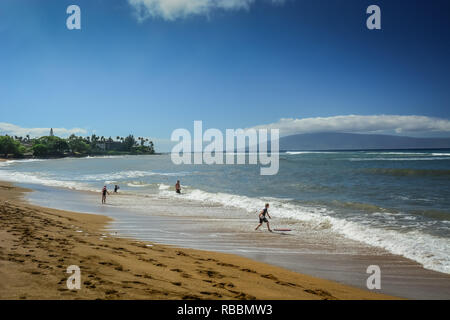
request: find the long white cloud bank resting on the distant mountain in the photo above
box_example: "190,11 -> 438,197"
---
253,115 -> 450,136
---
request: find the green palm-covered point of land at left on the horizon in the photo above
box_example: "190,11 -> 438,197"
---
0,129 -> 155,158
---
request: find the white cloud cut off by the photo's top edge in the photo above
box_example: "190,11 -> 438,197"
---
128,0 -> 284,21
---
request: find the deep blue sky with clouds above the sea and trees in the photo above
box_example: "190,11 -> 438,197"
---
0,0 -> 450,151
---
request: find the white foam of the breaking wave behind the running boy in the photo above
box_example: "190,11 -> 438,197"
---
162,189 -> 450,273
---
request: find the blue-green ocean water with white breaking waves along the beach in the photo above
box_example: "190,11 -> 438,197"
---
0,150 -> 450,274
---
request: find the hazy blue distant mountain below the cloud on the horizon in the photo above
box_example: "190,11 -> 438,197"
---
280,132 -> 450,151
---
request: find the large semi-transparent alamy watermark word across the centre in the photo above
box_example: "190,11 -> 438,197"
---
170,121 -> 279,175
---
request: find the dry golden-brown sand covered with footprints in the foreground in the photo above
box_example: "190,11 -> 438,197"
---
0,182 -> 397,300
